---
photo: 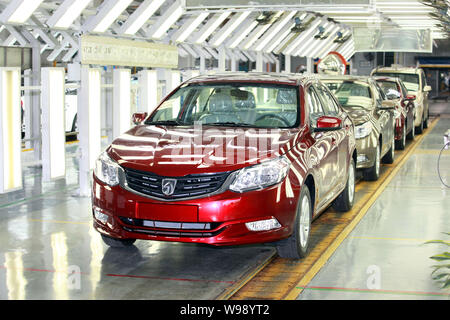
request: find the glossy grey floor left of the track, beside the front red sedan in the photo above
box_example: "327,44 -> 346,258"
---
0,144 -> 274,299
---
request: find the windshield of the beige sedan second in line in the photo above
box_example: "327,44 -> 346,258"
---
324,80 -> 372,109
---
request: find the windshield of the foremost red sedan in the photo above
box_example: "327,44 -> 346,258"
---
145,83 -> 300,128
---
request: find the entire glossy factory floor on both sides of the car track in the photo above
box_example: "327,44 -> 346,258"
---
0,102 -> 450,299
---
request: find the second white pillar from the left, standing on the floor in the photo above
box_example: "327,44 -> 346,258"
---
41,68 -> 66,181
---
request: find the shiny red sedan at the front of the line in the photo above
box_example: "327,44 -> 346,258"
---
92,73 -> 357,258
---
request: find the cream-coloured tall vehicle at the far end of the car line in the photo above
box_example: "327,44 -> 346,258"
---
370,65 -> 431,134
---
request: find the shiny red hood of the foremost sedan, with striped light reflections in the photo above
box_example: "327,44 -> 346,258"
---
107,125 -> 301,177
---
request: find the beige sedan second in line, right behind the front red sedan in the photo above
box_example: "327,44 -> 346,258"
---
321,75 -> 395,181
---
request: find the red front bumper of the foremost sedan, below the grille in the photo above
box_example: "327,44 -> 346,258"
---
92,176 -> 300,245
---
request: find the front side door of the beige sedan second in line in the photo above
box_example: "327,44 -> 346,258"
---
372,83 -> 395,155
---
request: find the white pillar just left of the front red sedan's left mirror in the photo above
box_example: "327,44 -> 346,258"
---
113,69 -> 131,139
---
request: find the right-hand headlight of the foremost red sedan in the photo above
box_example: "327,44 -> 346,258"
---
230,157 -> 289,192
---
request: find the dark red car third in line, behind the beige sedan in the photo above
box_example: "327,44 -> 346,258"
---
375,77 -> 416,150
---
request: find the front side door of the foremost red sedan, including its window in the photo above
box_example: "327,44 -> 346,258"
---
305,85 -> 338,211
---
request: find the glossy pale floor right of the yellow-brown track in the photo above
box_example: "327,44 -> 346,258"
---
298,104 -> 450,300
